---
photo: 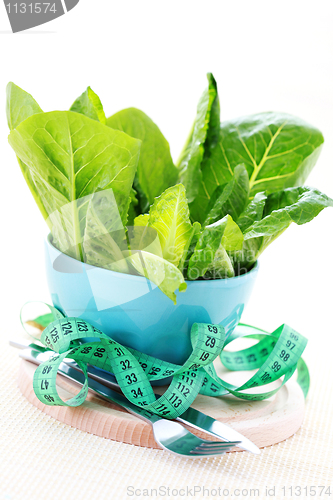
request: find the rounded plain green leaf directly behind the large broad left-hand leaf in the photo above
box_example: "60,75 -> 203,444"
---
106,108 -> 178,210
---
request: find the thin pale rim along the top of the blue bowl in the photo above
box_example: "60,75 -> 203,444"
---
45,233 -> 259,286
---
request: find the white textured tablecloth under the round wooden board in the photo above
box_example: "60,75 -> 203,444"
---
0,332 -> 333,500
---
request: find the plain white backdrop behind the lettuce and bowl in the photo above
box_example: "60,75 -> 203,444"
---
0,0 -> 333,352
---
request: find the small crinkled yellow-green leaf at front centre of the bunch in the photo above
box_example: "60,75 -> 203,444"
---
148,184 -> 192,266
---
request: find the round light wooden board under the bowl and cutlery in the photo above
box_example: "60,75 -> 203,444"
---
18,360 -> 304,451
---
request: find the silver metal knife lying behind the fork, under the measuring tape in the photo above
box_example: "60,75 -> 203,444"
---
9,340 -> 260,455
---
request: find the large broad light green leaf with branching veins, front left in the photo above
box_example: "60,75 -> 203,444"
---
9,111 -> 140,260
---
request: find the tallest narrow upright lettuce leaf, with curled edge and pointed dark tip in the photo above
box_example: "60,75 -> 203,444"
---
177,73 -> 220,201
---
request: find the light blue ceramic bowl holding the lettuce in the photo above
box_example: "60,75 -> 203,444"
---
45,235 -> 258,364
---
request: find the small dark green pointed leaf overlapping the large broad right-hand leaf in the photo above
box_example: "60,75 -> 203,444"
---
204,165 -> 249,226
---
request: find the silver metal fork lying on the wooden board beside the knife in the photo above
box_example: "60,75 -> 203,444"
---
20,349 -> 240,458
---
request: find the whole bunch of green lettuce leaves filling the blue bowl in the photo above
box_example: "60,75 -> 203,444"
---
6,78 -> 333,303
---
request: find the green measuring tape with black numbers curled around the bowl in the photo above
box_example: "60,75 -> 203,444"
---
22,306 -> 310,419
